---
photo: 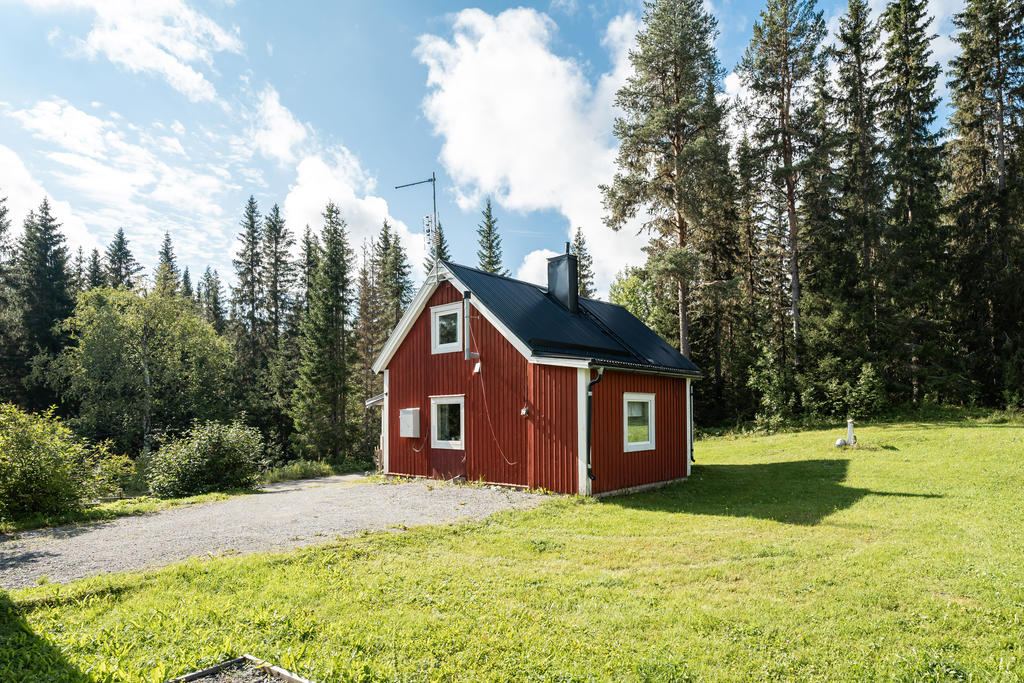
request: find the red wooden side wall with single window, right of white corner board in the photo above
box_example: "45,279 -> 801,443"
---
591,370 -> 687,494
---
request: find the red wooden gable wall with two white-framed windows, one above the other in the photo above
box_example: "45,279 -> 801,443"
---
388,283 -> 529,485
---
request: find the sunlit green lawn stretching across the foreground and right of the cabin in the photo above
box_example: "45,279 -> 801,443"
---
0,422 -> 1024,682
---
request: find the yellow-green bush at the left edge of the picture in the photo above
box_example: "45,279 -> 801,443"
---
0,403 -> 132,519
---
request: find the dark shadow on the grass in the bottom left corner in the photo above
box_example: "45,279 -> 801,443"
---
0,591 -> 92,683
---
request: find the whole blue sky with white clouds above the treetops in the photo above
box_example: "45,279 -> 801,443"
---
0,0 -> 959,295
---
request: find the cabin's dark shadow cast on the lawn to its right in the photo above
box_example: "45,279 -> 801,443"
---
606,460 -> 941,525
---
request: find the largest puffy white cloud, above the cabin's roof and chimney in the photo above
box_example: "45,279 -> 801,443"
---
416,8 -> 645,291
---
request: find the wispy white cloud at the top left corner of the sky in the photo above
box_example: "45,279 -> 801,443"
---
28,0 -> 243,102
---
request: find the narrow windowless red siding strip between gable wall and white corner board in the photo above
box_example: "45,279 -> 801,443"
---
529,365 -> 580,494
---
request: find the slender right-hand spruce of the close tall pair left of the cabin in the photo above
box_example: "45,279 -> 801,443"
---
260,204 -> 295,352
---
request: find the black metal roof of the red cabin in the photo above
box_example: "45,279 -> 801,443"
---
441,261 -> 701,377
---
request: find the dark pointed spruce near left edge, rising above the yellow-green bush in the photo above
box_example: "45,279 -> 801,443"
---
16,199 -> 75,366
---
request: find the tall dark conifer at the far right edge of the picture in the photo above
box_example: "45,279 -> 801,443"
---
945,0 -> 1024,403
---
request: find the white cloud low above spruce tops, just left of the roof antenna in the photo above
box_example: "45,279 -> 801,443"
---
283,147 -> 426,280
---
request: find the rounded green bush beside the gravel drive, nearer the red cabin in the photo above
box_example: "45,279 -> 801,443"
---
146,422 -> 263,498
